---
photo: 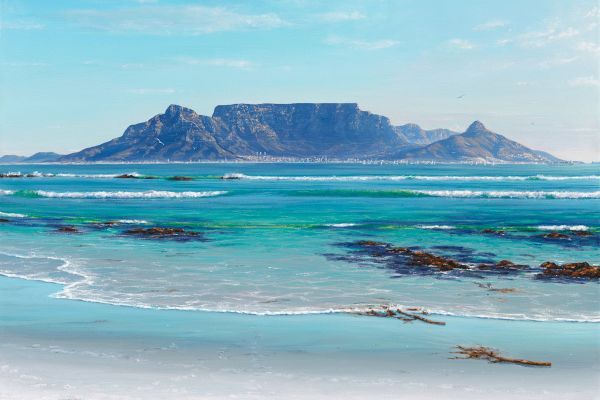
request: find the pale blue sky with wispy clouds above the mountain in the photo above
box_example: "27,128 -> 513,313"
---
0,0 -> 600,161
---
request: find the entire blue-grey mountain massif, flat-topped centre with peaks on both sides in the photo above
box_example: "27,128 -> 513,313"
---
30,103 -> 557,162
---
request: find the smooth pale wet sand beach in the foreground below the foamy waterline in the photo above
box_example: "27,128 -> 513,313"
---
0,277 -> 600,400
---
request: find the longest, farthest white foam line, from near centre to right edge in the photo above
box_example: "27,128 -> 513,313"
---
222,173 -> 600,182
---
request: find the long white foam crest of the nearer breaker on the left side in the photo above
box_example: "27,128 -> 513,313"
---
34,190 -> 227,199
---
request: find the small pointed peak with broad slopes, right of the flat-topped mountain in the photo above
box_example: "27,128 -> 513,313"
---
394,121 -> 557,162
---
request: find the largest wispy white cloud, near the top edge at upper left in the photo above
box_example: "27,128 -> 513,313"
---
65,5 -> 287,35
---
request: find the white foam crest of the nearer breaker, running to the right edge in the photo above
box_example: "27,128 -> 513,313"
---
408,190 -> 600,199
